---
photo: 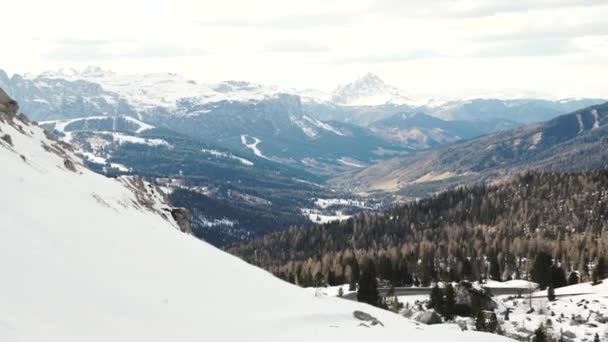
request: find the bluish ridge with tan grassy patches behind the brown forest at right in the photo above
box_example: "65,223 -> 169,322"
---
334,103 -> 608,197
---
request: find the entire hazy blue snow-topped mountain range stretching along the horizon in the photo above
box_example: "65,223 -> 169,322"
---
0,67 -> 604,176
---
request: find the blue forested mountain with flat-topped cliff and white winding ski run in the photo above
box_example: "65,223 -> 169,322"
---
149,94 -> 409,175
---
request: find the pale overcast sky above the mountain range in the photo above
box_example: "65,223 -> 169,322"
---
0,0 -> 608,98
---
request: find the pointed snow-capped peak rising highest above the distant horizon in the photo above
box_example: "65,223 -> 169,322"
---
332,73 -> 419,106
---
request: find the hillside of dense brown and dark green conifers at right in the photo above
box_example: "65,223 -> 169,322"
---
230,169 -> 608,286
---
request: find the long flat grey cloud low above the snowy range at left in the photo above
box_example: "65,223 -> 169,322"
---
45,40 -> 209,61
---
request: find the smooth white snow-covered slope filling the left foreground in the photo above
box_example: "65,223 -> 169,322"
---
0,95 -> 504,342
